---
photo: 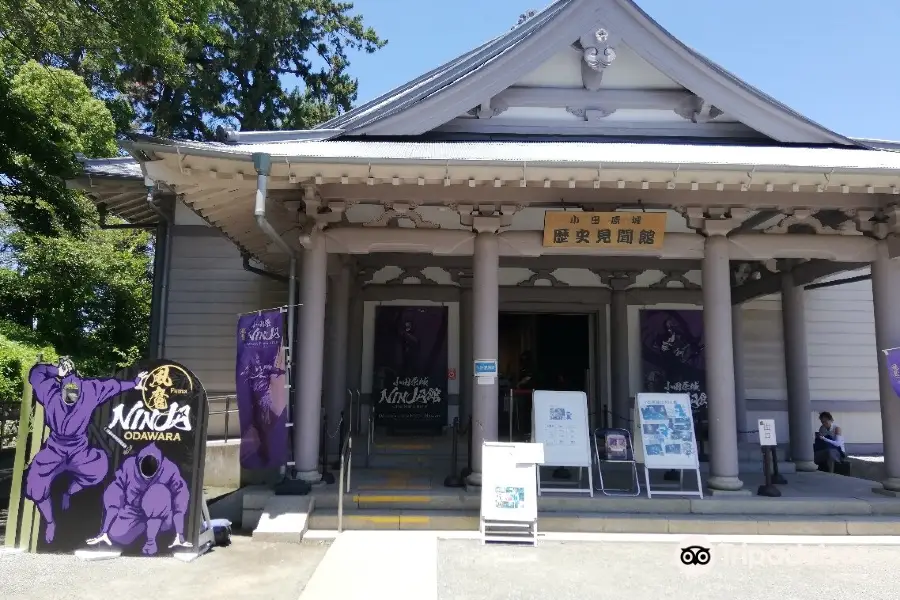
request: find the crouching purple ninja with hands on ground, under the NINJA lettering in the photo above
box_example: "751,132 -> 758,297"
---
87,443 -> 191,556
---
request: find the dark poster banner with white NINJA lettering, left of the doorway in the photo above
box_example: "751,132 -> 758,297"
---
372,306 -> 447,428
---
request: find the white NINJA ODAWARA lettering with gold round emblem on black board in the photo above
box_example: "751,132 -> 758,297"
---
108,365 -> 194,442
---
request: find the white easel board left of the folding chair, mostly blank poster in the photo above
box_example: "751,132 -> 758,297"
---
531,390 -> 594,498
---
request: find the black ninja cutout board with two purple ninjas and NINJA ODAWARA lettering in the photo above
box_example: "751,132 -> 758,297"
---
9,358 -> 209,556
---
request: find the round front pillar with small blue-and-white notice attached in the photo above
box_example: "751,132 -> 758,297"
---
467,231 -> 500,485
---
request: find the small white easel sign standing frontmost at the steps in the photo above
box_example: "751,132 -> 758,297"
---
480,442 -> 544,545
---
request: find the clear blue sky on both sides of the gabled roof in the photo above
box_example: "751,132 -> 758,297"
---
340,0 -> 900,140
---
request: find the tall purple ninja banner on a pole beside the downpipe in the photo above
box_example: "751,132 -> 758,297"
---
235,310 -> 288,469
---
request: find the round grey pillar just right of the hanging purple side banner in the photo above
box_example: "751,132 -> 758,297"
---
294,229 -> 328,481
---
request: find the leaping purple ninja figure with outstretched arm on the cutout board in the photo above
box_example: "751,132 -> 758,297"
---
25,357 -> 147,544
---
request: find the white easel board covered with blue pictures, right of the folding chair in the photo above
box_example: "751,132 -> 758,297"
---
635,394 -> 703,498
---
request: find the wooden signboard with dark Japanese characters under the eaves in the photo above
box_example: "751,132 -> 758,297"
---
544,211 -> 666,250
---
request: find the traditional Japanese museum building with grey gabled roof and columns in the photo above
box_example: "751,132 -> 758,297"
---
75,0 -> 900,490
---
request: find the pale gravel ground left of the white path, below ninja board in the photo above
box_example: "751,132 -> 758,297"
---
0,536 -> 328,600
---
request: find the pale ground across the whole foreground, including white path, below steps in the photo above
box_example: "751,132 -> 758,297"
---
0,531 -> 900,600
